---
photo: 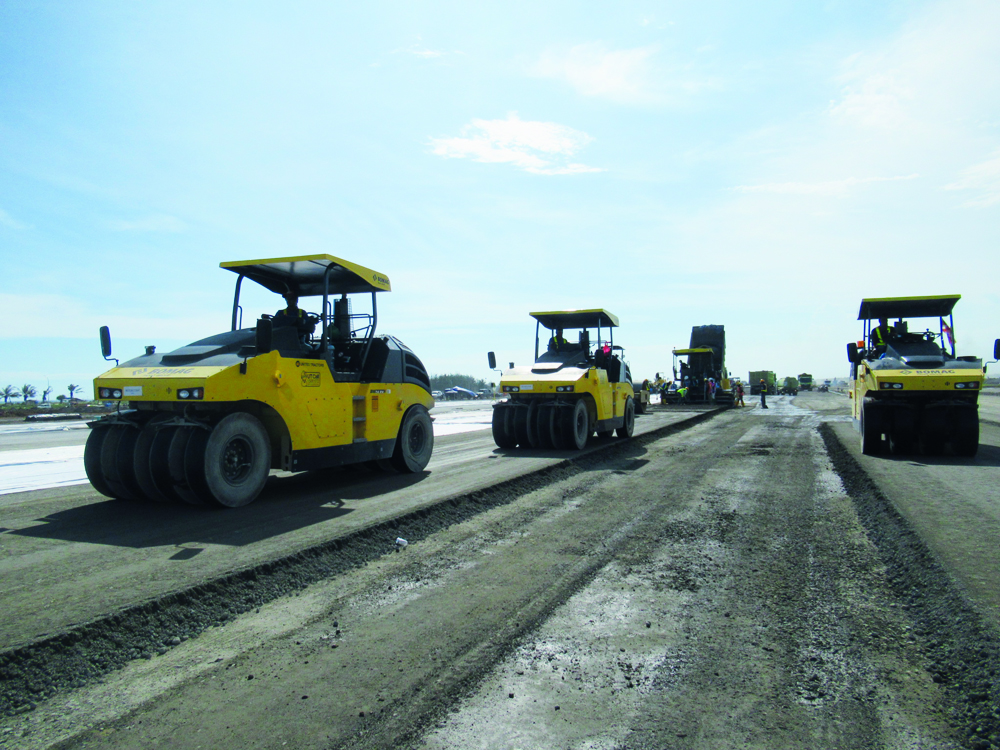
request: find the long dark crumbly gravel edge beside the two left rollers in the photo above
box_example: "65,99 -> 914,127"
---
0,409 -> 723,716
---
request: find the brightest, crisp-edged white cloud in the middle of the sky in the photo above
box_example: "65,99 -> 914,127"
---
430,112 -> 604,175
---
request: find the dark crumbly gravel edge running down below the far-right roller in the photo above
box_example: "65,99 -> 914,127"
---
818,424 -> 1000,750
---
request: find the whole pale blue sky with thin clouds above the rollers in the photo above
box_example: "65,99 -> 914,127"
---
0,0 -> 1000,395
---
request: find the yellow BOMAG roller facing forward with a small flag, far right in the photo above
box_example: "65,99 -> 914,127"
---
847,294 -> 1000,456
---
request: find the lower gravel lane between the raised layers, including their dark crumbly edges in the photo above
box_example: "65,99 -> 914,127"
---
0,394 -> 1000,749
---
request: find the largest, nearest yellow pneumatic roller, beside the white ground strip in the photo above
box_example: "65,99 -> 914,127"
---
84,255 -> 434,507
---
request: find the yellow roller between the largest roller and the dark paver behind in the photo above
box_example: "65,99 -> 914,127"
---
489,309 -> 636,450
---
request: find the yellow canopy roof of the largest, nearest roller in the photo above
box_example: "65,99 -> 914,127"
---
219,255 -> 390,297
